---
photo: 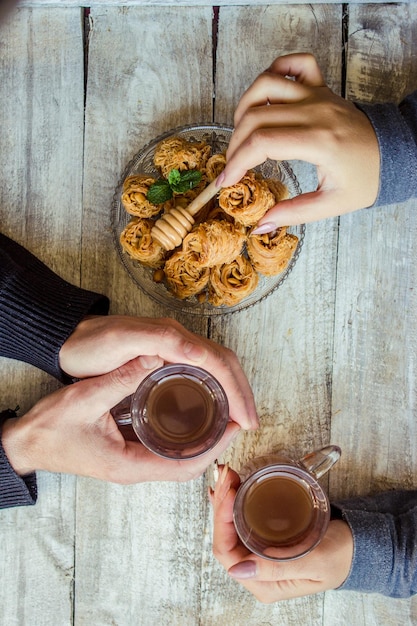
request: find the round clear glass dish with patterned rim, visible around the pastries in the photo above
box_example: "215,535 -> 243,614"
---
112,124 -> 304,316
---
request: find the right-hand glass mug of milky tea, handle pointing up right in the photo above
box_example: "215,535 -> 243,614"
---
233,445 -> 341,561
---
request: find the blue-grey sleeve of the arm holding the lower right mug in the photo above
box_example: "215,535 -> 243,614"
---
332,490 -> 417,598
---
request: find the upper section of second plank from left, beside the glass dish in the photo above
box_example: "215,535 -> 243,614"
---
83,8 -> 212,330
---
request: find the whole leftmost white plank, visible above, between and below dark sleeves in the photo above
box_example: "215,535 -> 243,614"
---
0,8 -> 83,626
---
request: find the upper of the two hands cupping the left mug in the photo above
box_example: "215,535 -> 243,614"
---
59,315 -> 258,429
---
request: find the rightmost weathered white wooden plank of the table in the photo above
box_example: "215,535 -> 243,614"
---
325,5 -> 417,626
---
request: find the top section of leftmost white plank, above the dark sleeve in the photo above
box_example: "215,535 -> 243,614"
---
0,9 -> 84,281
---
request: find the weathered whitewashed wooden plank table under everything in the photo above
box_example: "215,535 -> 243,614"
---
0,0 -> 417,626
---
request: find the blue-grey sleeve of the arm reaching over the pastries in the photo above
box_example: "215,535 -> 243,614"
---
356,91 -> 417,206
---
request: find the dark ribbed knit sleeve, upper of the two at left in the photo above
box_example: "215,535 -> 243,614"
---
0,234 -> 109,382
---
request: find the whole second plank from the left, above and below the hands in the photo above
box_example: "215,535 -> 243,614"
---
75,8 -> 212,626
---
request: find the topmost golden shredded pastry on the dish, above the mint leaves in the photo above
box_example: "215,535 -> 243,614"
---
154,137 -> 211,178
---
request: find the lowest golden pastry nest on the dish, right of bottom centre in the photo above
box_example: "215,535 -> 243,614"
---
208,255 -> 259,306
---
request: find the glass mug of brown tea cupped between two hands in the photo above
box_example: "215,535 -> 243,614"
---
111,364 -> 229,460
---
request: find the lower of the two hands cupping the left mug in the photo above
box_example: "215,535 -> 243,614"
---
2,359 -> 239,484
